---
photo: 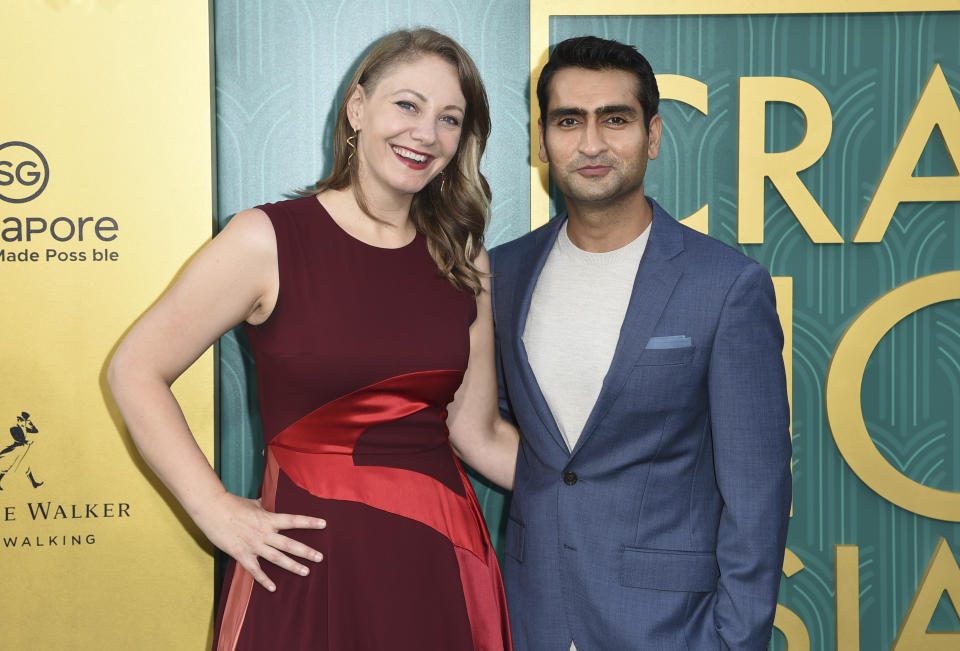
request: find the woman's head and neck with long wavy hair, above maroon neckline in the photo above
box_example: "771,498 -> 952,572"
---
316,29 -> 490,292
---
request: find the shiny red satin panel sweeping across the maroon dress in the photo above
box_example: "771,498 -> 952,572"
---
267,370 -> 510,651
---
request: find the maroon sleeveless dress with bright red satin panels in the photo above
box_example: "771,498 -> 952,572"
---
214,197 -> 510,651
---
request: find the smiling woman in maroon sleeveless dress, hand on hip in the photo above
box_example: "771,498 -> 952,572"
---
109,29 -> 517,650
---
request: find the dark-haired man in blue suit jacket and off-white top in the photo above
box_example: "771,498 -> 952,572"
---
491,37 -> 791,651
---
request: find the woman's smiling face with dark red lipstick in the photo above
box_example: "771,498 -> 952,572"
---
347,55 -> 467,206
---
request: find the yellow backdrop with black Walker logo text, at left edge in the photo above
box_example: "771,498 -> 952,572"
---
0,0 -> 214,649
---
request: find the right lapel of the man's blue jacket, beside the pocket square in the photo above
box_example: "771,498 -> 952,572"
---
571,208 -> 683,456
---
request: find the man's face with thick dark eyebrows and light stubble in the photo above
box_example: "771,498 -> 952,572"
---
540,68 -> 662,205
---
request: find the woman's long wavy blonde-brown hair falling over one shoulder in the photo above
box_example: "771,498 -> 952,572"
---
311,29 -> 490,294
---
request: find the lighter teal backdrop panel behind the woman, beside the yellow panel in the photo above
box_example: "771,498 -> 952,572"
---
215,0 -> 530,549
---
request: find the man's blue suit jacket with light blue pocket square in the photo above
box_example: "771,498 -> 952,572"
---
491,201 -> 791,651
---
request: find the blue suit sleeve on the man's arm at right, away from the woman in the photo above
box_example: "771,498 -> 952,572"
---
708,264 -> 792,651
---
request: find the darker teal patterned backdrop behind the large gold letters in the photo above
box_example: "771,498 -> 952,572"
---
550,13 -> 960,651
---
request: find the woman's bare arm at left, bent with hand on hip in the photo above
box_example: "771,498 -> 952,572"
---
107,210 -> 326,591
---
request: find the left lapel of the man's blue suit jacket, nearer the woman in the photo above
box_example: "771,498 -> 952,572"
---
510,214 -> 569,455
